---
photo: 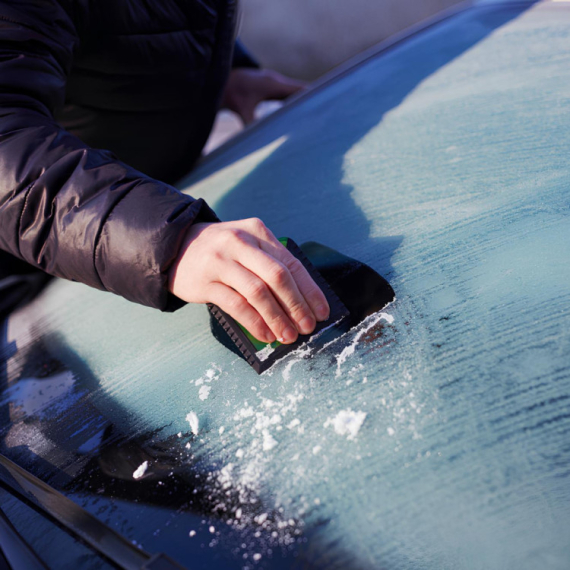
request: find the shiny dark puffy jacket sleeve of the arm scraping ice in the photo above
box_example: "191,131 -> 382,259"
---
0,0 -> 217,310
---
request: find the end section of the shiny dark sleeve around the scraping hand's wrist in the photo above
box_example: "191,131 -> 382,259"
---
95,181 -> 219,311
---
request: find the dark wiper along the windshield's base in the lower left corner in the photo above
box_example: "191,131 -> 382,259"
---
0,454 -> 184,570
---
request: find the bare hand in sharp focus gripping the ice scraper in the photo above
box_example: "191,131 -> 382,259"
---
168,218 -> 330,344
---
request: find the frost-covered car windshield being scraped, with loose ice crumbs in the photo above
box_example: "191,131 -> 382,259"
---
0,2 -> 570,570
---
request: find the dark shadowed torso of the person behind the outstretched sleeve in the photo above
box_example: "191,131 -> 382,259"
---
57,0 -> 236,181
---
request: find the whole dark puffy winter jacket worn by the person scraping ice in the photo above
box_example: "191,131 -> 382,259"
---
0,0 -> 236,310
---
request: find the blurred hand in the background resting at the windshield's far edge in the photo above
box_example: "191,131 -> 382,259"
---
222,67 -> 306,125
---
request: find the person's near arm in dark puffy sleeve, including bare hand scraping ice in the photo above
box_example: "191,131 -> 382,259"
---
0,0 -> 328,338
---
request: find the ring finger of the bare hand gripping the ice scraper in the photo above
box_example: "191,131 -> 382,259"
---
224,263 -> 300,344
